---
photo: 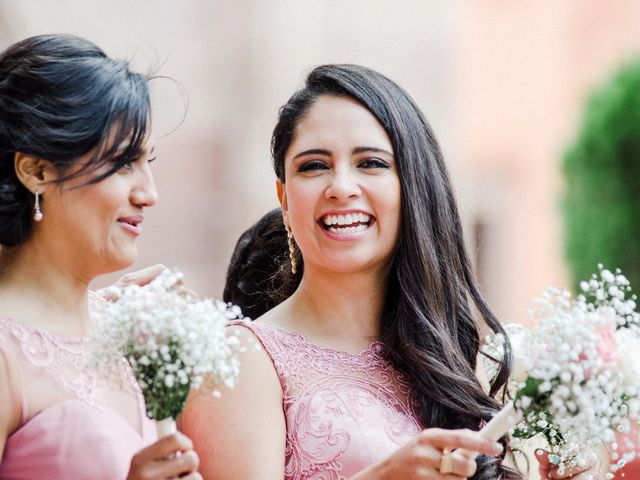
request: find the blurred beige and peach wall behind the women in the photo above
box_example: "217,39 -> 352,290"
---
0,0 -> 640,322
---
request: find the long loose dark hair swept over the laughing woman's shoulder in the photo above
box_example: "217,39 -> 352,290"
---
271,65 -> 521,480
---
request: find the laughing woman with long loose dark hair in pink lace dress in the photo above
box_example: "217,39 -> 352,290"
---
181,65 -> 521,480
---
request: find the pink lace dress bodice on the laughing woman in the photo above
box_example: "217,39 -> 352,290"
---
237,322 -> 422,480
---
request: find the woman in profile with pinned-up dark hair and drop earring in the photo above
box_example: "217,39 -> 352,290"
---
0,35 -> 201,480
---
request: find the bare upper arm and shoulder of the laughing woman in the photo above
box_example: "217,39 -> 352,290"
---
179,318 -> 286,480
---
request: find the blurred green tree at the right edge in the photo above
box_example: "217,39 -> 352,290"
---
563,59 -> 640,292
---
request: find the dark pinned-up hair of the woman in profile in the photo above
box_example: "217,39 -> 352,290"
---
0,35 -> 150,246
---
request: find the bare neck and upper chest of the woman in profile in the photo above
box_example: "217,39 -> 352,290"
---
0,241 -> 92,335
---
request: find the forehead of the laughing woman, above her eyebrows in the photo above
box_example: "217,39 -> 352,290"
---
292,95 -> 391,149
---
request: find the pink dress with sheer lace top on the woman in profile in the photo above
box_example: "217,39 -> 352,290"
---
0,295 -> 156,480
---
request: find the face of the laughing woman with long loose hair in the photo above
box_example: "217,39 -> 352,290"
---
277,95 -> 400,274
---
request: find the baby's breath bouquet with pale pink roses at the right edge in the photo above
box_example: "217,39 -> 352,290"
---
483,265 -> 640,477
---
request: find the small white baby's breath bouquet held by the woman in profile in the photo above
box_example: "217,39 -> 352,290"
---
91,270 -> 246,436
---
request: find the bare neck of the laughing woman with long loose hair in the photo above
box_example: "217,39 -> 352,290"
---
288,265 -> 388,348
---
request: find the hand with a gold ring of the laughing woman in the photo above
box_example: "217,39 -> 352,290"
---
350,428 -> 502,480
